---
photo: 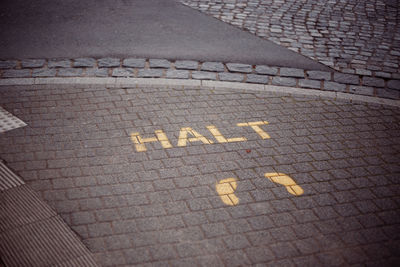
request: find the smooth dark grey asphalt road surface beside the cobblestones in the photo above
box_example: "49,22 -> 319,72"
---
0,0 -> 329,70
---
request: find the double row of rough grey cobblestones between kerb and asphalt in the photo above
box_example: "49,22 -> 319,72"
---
0,58 -> 400,99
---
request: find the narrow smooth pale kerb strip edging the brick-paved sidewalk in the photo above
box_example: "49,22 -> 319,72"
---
0,77 -> 400,107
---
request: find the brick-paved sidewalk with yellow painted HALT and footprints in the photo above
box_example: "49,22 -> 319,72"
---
0,85 -> 400,266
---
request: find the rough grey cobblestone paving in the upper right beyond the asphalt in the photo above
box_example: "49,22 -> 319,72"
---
181,0 -> 400,78
